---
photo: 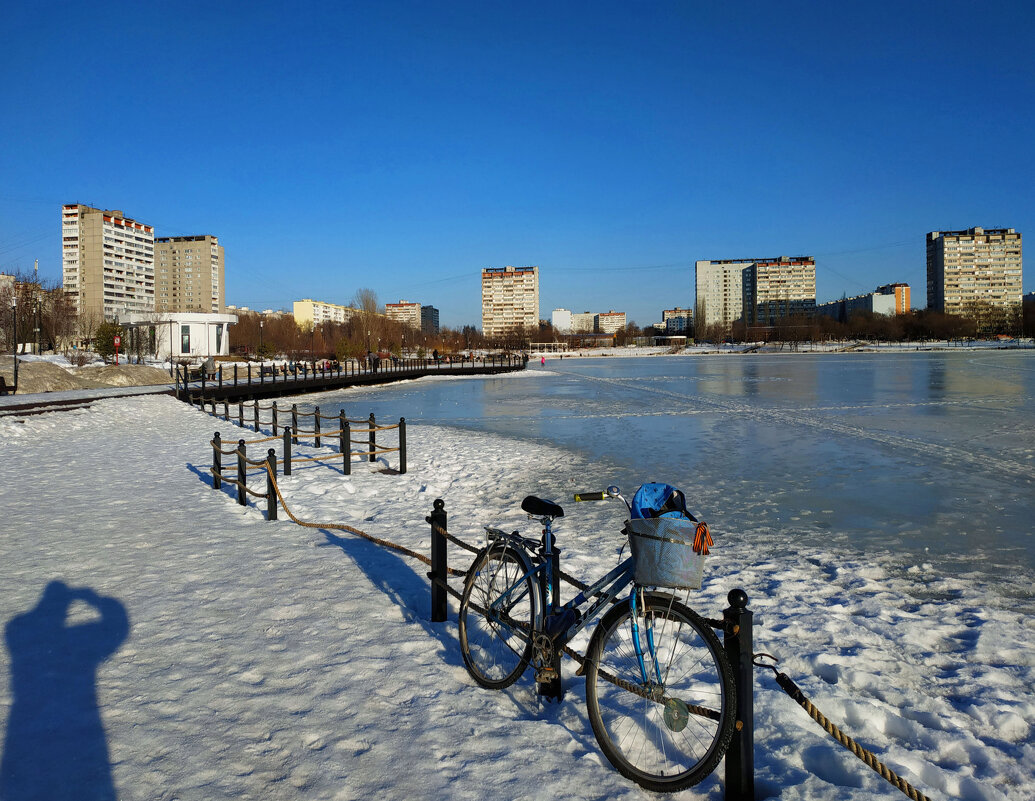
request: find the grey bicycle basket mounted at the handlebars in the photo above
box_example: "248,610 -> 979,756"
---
625,517 -> 705,590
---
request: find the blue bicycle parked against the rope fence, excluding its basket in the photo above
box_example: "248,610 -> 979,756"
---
460,486 -> 736,792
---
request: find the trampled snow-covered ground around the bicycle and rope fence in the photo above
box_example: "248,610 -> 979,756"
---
0,384 -> 1035,801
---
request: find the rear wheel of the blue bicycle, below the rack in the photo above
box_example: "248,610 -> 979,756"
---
460,544 -> 536,689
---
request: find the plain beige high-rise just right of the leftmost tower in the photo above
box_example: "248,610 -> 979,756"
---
154,235 -> 227,315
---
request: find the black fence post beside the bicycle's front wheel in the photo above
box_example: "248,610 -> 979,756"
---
722,589 -> 755,801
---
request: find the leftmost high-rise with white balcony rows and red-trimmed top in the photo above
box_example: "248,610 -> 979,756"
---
61,203 -> 154,322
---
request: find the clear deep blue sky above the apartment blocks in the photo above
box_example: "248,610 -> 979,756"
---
0,0 -> 1035,326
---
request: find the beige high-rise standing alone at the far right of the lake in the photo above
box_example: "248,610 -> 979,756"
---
927,228 -> 1023,317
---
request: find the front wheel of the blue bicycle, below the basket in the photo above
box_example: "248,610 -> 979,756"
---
586,593 -> 736,792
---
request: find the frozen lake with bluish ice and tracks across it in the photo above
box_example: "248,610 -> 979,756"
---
302,351 -> 1035,586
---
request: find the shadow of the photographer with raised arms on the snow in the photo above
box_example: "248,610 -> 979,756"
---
0,582 -> 129,801
